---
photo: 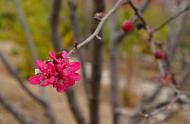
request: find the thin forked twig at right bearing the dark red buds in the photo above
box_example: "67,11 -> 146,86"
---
128,0 -> 189,122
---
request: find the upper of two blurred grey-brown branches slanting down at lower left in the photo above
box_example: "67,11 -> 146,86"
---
0,52 -> 57,124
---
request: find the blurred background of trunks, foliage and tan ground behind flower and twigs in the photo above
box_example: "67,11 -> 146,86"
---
0,0 -> 190,124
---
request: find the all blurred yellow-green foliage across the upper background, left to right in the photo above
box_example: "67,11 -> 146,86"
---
0,0 -> 190,77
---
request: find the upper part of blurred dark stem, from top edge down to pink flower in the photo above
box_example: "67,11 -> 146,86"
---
50,0 -> 62,52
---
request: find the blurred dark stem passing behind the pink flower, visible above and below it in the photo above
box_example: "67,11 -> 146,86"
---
50,0 -> 85,124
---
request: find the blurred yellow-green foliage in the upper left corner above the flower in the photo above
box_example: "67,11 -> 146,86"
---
0,0 -> 85,77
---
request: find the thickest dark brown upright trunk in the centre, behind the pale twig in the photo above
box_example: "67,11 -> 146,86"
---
89,0 -> 105,124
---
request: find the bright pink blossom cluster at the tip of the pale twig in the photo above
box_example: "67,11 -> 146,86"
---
28,51 -> 80,92
